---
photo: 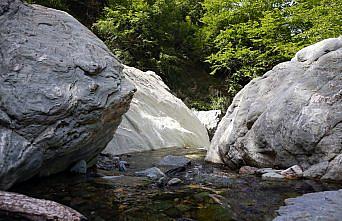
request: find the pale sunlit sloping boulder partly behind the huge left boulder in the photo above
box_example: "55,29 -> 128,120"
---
104,66 -> 210,154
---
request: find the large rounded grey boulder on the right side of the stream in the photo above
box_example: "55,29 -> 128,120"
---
206,38 -> 342,180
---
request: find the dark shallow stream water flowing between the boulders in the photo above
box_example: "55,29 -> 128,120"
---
4,148 -> 342,221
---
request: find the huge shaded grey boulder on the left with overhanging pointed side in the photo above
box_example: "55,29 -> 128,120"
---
0,0 -> 134,189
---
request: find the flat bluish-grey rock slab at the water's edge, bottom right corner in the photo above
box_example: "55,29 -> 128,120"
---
273,190 -> 342,221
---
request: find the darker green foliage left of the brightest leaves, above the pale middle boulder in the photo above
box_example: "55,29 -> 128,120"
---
93,0 -> 201,77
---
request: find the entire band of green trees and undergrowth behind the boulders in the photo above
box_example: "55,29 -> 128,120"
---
26,0 -> 342,108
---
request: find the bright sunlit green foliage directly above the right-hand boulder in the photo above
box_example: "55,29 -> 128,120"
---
198,0 -> 342,95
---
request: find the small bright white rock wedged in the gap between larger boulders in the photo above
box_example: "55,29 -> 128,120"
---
193,110 -> 222,137
